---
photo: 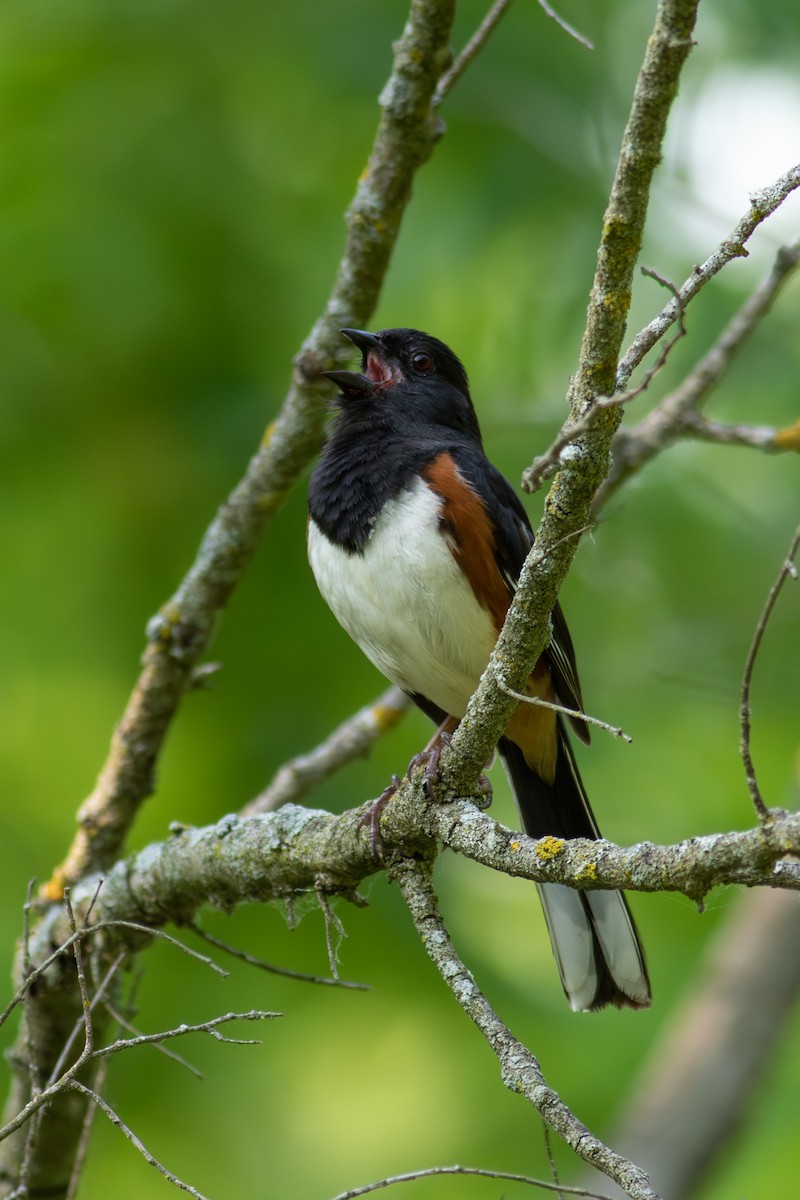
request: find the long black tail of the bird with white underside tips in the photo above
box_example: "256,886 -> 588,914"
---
498,718 -> 650,1012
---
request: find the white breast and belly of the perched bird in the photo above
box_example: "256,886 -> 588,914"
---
308,480 -> 497,716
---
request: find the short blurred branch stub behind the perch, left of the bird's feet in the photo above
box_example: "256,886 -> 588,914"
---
242,688 -> 411,817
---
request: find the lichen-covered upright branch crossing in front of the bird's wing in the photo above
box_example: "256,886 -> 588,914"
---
441,0 -> 698,794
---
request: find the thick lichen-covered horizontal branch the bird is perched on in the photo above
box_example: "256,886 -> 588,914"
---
45,796 -> 800,944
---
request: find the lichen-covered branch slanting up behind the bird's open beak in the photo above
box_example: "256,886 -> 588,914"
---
50,0 -> 455,896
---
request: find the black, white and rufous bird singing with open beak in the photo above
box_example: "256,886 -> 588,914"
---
307,328 -> 651,1012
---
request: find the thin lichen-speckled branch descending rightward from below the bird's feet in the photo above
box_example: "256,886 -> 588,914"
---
395,859 -> 657,1200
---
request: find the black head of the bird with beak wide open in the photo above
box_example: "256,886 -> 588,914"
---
323,329 -> 481,442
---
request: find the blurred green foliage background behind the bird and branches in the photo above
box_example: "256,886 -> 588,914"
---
0,0 -> 800,1200
